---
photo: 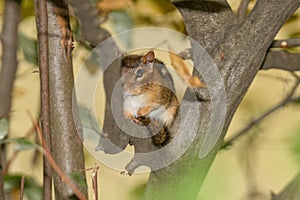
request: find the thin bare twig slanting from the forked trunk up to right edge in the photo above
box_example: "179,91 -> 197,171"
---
222,73 -> 300,148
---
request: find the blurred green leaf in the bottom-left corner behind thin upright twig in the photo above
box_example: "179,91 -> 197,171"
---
4,174 -> 43,200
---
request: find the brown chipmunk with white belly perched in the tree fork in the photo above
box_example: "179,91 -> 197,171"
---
121,51 -> 179,147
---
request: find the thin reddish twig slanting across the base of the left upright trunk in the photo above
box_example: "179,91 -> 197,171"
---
28,112 -> 86,200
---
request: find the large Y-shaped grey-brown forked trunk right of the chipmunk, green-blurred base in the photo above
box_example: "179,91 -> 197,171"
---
144,0 -> 300,199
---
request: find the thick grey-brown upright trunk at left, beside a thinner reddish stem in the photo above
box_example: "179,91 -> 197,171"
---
47,0 -> 87,199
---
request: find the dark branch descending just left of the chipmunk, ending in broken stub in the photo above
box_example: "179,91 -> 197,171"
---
69,0 -> 129,154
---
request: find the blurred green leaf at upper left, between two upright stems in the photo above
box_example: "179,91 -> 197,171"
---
18,32 -> 38,66
